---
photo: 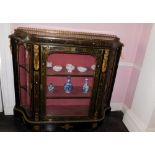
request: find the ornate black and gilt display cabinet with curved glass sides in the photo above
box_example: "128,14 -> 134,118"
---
10,28 -> 123,130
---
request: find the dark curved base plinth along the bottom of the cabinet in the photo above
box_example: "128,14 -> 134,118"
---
14,108 -> 103,132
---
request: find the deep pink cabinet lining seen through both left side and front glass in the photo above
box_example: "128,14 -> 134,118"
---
19,48 -> 96,113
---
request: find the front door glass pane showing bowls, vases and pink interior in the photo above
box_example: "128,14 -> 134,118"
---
46,53 -> 96,116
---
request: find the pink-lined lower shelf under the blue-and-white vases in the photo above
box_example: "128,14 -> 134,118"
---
46,86 -> 92,99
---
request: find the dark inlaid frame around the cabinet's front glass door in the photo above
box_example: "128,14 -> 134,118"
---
40,45 -> 103,120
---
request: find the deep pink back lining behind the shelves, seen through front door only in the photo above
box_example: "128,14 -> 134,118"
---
46,54 -> 96,110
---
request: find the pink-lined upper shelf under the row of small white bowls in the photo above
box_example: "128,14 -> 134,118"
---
47,67 -> 95,77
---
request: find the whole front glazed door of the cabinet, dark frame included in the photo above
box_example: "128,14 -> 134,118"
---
40,45 -> 103,121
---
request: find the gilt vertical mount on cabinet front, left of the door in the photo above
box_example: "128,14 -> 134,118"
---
34,45 -> 39,70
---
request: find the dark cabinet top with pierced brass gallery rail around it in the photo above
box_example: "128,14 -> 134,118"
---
10,27 -> 123,48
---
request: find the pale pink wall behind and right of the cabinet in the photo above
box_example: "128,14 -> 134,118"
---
11,23 -> 152,107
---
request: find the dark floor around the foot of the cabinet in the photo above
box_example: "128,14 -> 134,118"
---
0,111 -> 128,132
